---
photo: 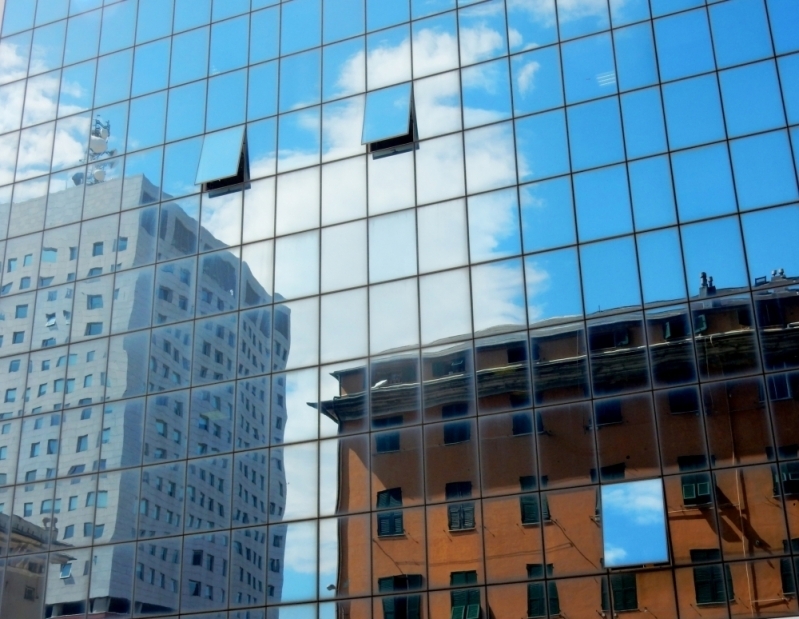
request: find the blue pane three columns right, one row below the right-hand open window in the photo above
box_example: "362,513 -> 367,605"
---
515,110 -> 569,183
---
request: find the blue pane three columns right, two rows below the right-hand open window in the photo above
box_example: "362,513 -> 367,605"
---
519,176 -> 576,253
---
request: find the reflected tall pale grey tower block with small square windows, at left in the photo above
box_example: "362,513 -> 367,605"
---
0,176 -> 290,618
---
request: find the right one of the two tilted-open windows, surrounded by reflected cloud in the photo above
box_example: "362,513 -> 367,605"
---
361,83 -> 416,158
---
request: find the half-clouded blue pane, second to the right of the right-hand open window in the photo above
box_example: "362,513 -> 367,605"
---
461,60 -> 511,129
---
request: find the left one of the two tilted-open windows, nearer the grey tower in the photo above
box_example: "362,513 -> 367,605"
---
194,125 -> 250,196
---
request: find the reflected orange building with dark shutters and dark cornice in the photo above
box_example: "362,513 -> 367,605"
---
320,274 -> 799,619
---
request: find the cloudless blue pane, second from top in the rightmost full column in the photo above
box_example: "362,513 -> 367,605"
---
719,60 -> 785,137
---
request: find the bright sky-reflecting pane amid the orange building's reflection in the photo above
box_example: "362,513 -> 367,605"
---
602,479 -> 669,568
